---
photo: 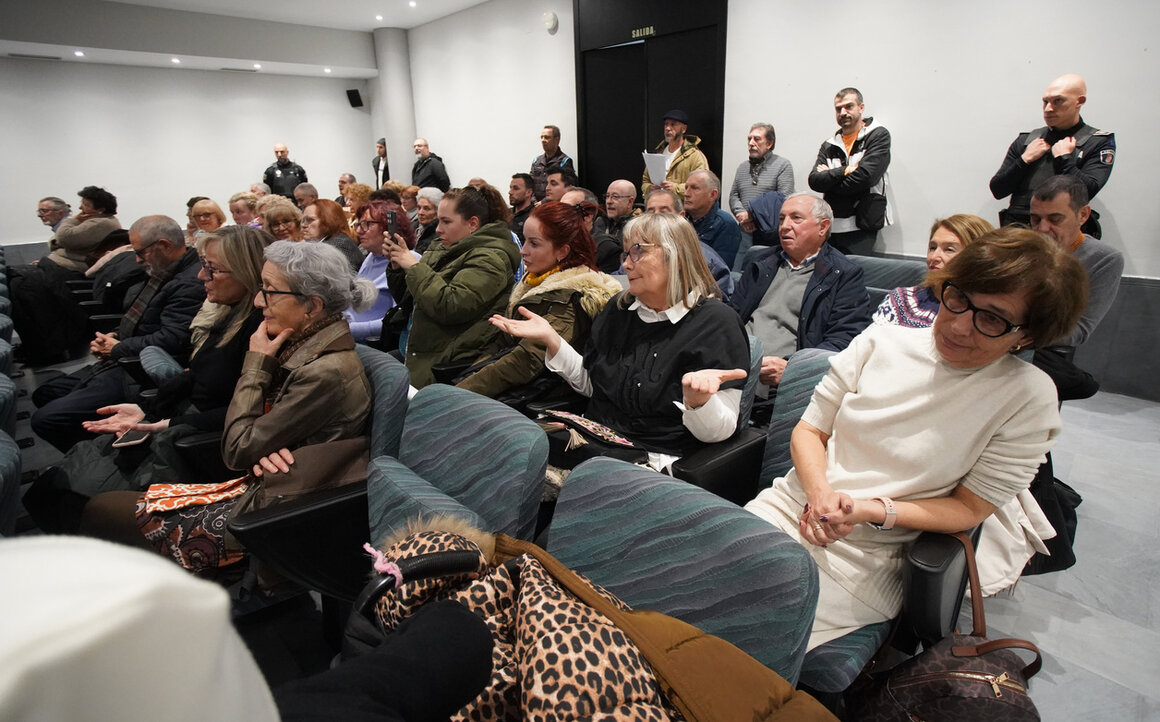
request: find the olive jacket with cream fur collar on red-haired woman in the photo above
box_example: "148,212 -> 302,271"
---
458,266 -> 623,397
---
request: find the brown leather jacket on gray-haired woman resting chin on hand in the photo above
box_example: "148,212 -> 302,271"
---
222,320 -> 370,470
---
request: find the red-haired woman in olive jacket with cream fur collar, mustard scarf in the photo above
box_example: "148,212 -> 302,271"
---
458,202 -> 622,397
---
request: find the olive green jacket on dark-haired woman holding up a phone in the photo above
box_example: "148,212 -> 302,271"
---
386,222 -> 520,389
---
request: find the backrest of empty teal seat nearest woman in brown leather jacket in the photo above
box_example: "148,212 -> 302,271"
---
398,384 -> 548,539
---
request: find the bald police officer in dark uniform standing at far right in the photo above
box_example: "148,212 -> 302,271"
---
991,74 -> 1116,238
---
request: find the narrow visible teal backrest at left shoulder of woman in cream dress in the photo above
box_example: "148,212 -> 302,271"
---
757,348 -> 834,489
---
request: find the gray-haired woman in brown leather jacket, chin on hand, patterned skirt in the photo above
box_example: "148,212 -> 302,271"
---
81,240 -> 378,578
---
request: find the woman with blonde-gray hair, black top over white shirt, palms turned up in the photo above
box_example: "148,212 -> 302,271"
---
492,214 -> 749,468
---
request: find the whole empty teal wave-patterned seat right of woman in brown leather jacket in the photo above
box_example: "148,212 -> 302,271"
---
367,384 -> 548,544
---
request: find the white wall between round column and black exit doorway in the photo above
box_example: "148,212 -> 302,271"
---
406,0 -> 577,195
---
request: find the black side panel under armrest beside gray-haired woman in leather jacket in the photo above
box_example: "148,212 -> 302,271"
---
229,482 -> 371,601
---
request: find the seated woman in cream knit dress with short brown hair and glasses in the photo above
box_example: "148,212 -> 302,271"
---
746,228 -> 1087,649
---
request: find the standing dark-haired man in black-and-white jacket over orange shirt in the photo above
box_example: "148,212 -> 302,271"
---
810,88 -> 890,255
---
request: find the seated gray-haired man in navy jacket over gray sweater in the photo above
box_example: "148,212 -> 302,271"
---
730,193 -> 870,408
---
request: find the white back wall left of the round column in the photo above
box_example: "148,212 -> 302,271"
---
0,58 -> 375,244
